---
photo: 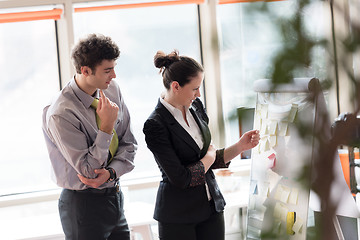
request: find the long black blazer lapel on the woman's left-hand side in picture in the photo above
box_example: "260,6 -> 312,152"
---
155,100 -> 200,152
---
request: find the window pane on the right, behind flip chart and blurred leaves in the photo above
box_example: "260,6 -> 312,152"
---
217,1 -> 326,147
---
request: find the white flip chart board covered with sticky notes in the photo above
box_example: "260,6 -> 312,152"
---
246,78 -> 317,240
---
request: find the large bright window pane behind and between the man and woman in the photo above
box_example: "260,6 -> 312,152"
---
74,4 -> 200,178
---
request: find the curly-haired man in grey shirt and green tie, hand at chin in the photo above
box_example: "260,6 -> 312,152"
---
43,34 -> 137,240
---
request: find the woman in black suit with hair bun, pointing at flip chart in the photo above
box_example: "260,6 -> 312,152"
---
143,51 -> 259,240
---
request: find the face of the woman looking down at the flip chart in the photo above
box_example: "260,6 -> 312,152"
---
178,72 -> 204,107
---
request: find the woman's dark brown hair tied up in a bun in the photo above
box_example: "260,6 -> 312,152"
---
154,50 -> 204,89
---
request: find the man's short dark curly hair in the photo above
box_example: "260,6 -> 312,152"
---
71,34 -> 120,73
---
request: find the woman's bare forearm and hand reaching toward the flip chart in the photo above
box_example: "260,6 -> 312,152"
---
224,130 -> 260,164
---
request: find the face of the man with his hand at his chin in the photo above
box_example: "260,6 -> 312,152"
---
87,60 -> 116,89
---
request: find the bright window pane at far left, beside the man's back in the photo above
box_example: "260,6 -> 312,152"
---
0,12 -> 60,195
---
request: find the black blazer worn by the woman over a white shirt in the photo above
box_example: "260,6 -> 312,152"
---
143,99 -> 228,223
